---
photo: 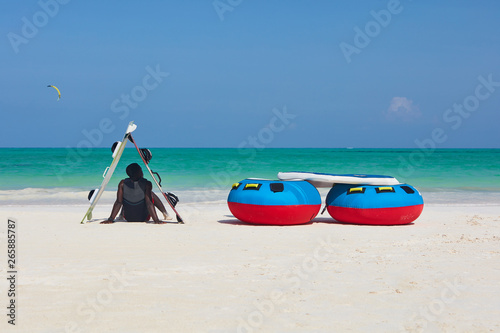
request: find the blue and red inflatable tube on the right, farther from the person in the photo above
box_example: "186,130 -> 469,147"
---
326,184 -> 424,225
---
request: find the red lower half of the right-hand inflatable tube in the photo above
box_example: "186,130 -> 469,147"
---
328,205 -> 424,225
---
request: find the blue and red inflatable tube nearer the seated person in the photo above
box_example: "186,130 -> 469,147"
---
227,179 -> 321,225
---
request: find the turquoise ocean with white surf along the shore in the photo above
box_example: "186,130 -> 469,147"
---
0,148 -> 500,205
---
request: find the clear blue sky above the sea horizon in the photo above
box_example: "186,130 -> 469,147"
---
0,0 -> 500,149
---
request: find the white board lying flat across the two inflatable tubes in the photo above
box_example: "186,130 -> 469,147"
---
278,172 -> 400,187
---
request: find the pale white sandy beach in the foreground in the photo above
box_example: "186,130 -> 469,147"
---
0,203 -> 500,332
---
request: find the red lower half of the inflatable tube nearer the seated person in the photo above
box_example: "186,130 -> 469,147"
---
227,202 -> 321,225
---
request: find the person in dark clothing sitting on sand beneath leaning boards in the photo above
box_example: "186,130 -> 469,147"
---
101,163 -> 172,224
